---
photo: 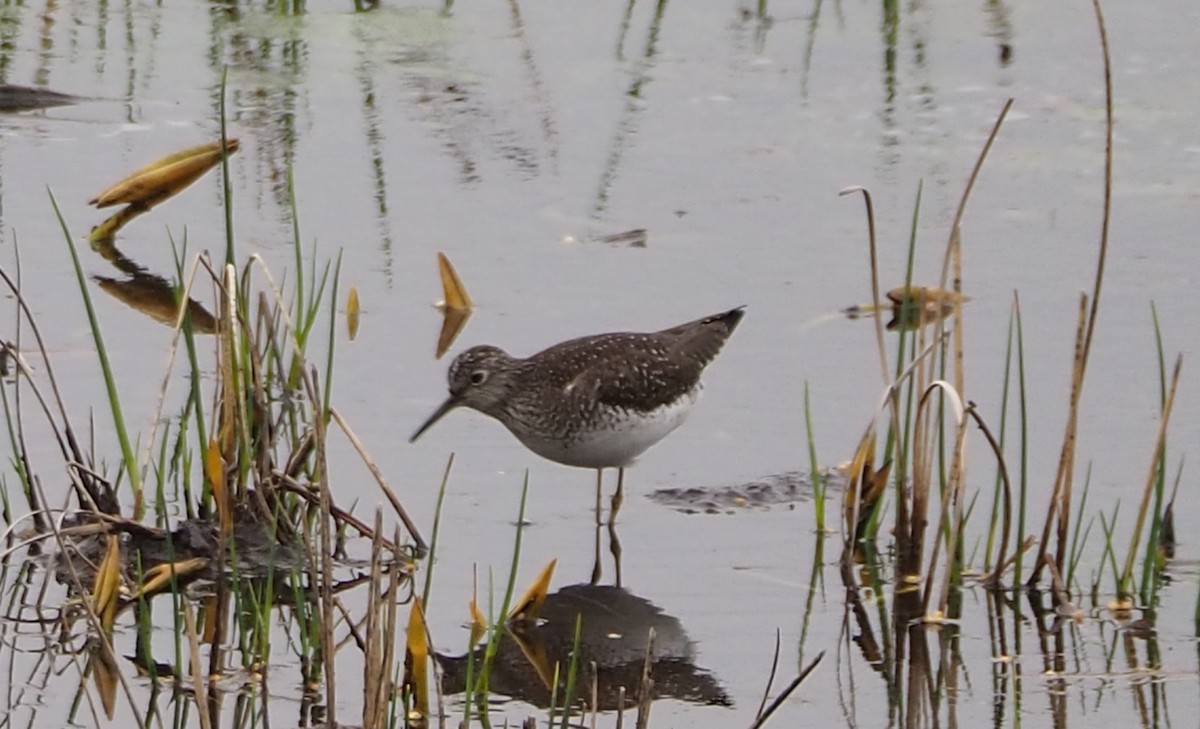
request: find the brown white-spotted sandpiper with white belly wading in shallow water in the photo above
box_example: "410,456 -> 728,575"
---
409,307 -> 744,522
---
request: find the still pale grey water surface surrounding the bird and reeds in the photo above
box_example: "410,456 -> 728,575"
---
0,0 -> 1200,725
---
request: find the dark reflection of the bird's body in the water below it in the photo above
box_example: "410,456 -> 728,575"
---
437,584 -> 733,711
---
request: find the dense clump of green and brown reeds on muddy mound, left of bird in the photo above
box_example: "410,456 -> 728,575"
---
0,98 -> 425,728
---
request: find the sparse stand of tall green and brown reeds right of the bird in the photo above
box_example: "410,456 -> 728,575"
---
815,7 -> 1185,725
